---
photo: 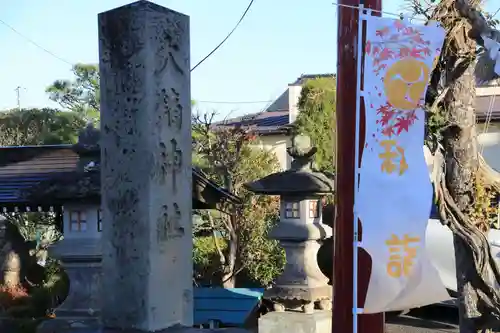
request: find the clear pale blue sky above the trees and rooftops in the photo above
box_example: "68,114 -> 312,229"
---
0,0 -> 498,115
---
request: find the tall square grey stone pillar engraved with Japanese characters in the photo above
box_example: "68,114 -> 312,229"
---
99,1 -> 193,332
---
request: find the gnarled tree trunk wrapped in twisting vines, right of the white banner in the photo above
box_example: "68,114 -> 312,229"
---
426,0 -> 500,333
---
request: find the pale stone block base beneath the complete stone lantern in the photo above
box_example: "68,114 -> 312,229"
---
259,311 -> 332,333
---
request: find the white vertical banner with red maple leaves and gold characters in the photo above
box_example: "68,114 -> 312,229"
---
356,14 -> 449,313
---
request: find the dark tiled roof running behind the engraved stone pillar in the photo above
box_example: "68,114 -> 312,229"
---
0,145 -> 239,205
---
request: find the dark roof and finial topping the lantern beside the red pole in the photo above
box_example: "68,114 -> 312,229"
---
245,135 -> 334,196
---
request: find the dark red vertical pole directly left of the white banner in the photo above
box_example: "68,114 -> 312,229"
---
332,0 -> 384,333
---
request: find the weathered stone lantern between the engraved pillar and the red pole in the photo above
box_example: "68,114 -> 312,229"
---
245,136 -> 334,313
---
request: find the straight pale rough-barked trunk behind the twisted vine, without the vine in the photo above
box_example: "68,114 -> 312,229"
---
443,64 -> 480,333
